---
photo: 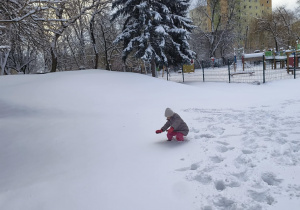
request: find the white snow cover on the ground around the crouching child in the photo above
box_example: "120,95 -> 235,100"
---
0,70 -> 300,210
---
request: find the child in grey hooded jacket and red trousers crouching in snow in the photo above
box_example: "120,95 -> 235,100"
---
156,108 -> 189,141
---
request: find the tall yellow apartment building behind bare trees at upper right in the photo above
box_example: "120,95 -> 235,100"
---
190,0 -> 272,47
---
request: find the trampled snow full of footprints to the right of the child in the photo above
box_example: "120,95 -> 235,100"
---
176,101 -> 300,210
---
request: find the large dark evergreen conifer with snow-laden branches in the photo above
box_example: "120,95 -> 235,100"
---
112,0 -> 195,76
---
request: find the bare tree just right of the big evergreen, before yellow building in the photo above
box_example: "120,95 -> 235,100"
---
192,0 -> 239,58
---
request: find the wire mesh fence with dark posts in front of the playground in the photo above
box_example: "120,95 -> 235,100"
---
158,57 -> 300,84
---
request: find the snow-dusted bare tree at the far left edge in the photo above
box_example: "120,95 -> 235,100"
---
0,0 -> 60,75
